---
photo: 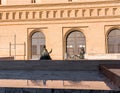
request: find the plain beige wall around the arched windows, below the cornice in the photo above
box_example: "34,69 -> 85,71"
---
0,22 -> 119,60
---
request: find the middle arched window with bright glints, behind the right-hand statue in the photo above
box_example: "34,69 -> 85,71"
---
66,31 -> 86,59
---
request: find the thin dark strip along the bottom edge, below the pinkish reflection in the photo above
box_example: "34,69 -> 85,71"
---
0,88 -> 119,93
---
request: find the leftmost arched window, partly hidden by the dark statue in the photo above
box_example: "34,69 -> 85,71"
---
32,32 -> 45,59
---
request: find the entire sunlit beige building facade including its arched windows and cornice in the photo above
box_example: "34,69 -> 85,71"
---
0,0 -> 120,60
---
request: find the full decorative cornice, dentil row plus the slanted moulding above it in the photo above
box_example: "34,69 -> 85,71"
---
0,1 -> 120,24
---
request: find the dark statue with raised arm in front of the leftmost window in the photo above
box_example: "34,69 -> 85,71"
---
40,46 -> 52,60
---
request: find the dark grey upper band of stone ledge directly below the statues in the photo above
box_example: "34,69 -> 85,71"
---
0,60 -> 120,71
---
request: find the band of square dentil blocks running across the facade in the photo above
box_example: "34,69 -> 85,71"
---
0,4 -> 120,22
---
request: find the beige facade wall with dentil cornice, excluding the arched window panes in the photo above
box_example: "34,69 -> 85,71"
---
0,1 -> 120,60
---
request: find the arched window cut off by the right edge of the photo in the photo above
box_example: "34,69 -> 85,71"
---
108,29 -> 120,53
